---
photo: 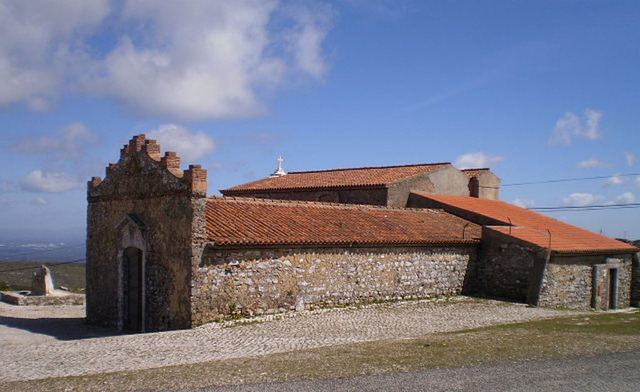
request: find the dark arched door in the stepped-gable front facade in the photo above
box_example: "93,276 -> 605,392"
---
123,247 -> 144,332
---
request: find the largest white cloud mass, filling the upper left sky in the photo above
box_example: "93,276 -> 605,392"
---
0,0 -> 334,120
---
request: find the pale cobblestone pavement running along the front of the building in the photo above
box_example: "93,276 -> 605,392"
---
0,297 -> 588,381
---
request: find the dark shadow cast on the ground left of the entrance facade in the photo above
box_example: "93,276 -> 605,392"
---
0,316 -> 123,340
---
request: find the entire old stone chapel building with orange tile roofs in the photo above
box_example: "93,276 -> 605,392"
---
87,135 -> 638,331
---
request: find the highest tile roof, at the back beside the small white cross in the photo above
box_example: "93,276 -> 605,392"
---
222,163 -> 451,195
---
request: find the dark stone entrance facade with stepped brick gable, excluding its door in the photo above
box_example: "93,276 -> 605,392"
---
86,135 -> 206,331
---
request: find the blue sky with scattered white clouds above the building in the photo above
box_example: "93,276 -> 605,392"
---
0,0 -> 640,239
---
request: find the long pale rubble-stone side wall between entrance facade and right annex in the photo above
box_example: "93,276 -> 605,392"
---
191,247 -> 476,325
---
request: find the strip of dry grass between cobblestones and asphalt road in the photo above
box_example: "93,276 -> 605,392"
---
0,310 -> 640,391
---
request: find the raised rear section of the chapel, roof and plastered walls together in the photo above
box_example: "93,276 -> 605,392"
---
220,162 -> 500,208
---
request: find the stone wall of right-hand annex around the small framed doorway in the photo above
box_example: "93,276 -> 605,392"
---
540,255 -> 632,309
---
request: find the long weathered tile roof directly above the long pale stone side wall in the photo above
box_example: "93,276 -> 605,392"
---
206,197 -> 481,245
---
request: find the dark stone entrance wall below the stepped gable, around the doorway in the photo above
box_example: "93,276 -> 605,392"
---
87,196 -> 191,331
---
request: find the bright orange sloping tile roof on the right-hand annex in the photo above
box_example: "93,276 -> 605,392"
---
412,194 -> 638,253
